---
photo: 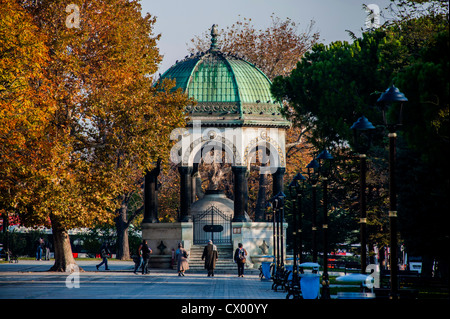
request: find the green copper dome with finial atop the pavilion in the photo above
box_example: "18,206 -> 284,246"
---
161,26 -> 289,127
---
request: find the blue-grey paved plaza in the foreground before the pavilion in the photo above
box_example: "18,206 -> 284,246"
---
0,260 -> 286,299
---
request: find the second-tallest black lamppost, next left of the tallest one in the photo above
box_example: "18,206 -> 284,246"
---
350,116 -> 375,274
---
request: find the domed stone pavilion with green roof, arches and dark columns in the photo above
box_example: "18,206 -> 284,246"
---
142,25 -> 290,270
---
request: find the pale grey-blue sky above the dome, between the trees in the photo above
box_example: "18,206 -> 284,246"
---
141,0 -> 390,74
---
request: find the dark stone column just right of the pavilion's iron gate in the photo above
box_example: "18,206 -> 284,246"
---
232,166 -> 248,222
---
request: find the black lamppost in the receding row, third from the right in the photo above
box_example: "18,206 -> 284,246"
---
316,150 -> 333,299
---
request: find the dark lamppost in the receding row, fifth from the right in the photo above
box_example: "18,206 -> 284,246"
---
289,173 -> 306,282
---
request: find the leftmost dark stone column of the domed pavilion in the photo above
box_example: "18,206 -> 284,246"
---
142,160 -> 161,223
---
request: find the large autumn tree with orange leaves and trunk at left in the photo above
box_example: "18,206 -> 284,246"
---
0,0 -> 188,271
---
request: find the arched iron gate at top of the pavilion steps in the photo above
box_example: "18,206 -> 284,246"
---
193,206 -> 231,245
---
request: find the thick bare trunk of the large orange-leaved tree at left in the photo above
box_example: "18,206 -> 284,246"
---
50,220 -> 80,272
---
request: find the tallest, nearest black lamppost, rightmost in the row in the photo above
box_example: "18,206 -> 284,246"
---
377,85 -> 408,299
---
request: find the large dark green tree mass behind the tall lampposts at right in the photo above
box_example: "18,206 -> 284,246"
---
272,1 -> 449,275
